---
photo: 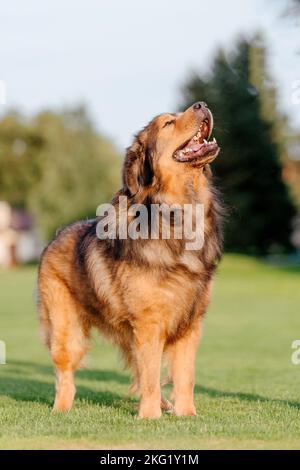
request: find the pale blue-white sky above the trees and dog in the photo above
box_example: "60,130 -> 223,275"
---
0,0 -> 300,148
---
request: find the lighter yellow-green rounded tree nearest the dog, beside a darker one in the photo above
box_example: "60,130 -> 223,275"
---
29,108 -> 120,237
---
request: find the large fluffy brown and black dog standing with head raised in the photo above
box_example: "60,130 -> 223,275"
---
38,102 -> 223,418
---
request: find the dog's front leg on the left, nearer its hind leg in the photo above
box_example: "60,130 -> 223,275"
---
134,322 -> 164,418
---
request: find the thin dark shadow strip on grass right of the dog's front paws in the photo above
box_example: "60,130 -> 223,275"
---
195,385 -> 300,410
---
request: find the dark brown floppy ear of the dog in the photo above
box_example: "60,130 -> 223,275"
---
122,138 -> 153,196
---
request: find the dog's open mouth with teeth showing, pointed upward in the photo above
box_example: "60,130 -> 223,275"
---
173,119 -> 220,162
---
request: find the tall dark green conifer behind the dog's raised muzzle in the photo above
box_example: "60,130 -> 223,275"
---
183,40 -> 295,254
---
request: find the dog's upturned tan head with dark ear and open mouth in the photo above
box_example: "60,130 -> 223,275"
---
123,102 -> 220,195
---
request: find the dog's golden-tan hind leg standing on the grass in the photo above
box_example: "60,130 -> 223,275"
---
41,279 -> 89,411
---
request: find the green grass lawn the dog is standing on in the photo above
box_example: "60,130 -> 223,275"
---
0,255 -> 300,449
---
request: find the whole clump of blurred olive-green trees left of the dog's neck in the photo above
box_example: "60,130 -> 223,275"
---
0,108 -> 120,239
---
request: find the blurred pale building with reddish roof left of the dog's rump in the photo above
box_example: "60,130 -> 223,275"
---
0,201 -> 41,267
